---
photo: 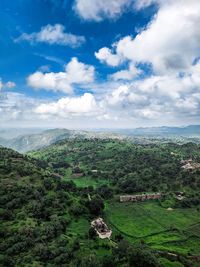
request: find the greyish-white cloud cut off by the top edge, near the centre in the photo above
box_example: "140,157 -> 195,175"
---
74,0 -> 133,21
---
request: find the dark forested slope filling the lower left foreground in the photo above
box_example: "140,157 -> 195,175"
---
0,147 -> 162,267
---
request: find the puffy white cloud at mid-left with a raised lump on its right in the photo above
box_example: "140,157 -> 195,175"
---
27,57 -> 95,93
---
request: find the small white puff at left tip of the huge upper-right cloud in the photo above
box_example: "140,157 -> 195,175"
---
95,47 -> 121,67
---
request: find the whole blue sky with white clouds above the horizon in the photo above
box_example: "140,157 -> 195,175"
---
0,0 -> 200,129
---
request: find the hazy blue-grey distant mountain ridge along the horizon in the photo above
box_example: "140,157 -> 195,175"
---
0,125 -> 200,153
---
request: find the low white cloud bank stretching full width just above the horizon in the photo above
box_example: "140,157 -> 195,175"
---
0,64 -> 200,128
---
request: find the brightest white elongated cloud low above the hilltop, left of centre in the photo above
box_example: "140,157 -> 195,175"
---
35,93 -> 98,118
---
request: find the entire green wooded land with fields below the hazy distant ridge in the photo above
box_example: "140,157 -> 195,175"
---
0,139 -> 200,267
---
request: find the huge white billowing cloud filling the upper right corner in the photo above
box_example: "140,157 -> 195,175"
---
95,0 -> 200,74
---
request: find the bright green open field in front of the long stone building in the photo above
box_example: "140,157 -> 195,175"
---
105,201 -> 200,255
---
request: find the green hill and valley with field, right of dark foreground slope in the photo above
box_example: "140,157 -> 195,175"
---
28,139 -> 200,266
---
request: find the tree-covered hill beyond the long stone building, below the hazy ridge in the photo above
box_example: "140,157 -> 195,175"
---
29,139 -> 200,196
